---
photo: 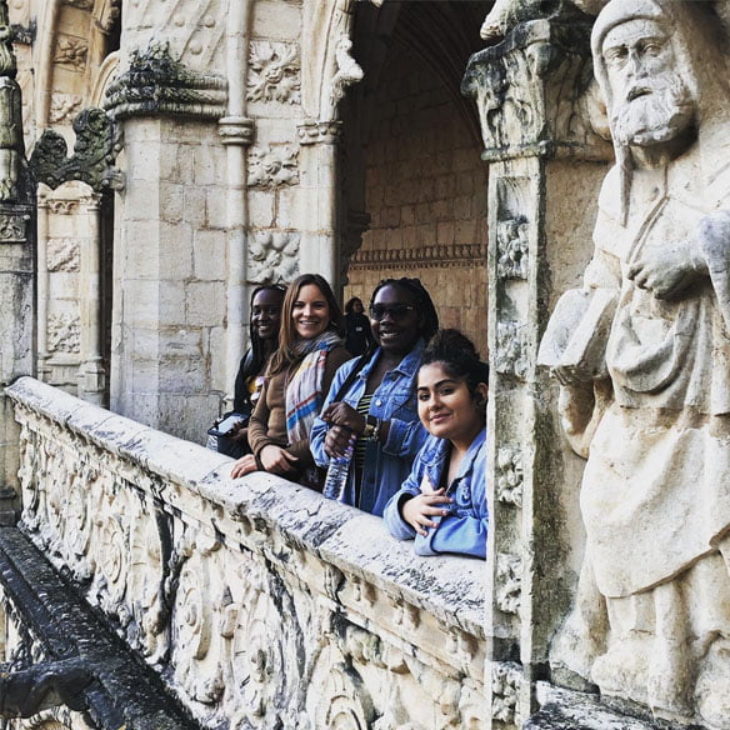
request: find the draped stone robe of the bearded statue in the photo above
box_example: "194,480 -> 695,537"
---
553,122 -> 730,727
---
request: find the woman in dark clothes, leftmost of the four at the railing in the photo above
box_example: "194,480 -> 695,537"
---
211,284 -> 286,459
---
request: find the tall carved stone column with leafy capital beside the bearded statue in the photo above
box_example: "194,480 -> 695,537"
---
462,19 -> 611,729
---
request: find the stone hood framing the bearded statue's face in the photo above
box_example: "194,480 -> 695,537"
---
591,0 -> 730,222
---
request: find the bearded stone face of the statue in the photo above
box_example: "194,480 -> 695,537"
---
601,19 -> 695,147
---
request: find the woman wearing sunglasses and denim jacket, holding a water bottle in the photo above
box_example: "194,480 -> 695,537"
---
310,278 -> 438,515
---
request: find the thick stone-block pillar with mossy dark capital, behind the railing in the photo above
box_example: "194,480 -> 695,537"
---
107,45 -> 228,442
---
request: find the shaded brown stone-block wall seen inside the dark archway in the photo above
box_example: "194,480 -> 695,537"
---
345,43 -> 487,355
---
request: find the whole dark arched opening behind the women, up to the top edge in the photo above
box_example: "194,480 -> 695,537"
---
341,1 -> 491,355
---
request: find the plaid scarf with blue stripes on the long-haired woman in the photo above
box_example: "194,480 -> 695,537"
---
286,330 -> 342,444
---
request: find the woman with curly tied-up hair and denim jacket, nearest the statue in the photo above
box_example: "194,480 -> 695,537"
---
384,330 -> 489,558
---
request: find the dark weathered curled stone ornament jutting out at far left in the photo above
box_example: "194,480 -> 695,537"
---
29,109 -> 123,191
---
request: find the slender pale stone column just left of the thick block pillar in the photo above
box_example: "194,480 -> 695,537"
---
78,193 -> 106,405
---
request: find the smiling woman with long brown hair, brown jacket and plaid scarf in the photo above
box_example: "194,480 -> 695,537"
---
231,274 -> 350,489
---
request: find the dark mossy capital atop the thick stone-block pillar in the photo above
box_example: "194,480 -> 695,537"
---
106,43 -> 228,120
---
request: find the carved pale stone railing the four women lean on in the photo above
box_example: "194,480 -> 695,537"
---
7,378 -> 486,730
